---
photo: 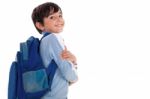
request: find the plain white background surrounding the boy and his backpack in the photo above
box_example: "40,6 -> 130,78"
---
0,0 -> 150,99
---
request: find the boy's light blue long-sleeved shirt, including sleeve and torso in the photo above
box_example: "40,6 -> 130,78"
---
40,33 -> 77,99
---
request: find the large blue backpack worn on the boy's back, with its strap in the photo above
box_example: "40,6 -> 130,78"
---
8,33 -> 57,99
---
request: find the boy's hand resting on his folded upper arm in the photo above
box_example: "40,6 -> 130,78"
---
61,47 -> 77,65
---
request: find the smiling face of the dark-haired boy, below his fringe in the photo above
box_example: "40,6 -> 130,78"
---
38,10 -> 64,33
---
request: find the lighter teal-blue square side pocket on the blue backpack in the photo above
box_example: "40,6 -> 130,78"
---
23,69 -> 49,93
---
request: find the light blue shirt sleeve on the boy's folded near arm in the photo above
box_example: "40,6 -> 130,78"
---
48,35 -> 78,82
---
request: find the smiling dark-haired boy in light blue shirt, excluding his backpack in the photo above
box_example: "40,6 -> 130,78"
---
32,2 -> 78,99
